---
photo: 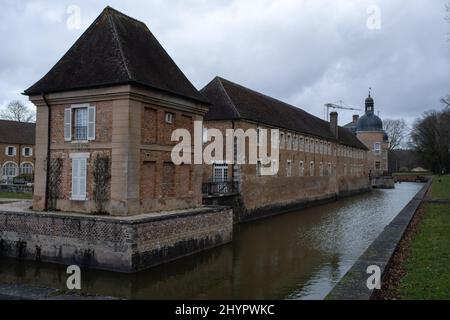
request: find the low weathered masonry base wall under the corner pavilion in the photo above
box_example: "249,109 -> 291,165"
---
0,207 -> 233,273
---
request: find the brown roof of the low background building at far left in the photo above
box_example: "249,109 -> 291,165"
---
0,120 -> 36,145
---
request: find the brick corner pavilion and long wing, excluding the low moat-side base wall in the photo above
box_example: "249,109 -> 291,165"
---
25,7 -> 369,219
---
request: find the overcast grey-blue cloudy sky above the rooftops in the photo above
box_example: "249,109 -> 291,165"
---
0,0 -> 450,124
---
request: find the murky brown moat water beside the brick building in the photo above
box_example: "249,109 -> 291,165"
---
0,183 -> 422,299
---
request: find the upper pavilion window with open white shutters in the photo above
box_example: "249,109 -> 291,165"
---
64,104 -> 96,141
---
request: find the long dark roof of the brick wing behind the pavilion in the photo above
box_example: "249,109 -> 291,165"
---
201,77 -> 367,150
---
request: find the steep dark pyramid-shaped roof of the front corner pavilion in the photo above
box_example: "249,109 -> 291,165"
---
25,7 -> 205,102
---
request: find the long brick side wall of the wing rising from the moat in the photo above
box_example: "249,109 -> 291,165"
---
203,121 -> 369,219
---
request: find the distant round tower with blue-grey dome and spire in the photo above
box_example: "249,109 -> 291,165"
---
356,91 -> 389,175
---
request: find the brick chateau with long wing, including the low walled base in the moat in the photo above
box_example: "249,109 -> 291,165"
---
0,7 -> 376,272
